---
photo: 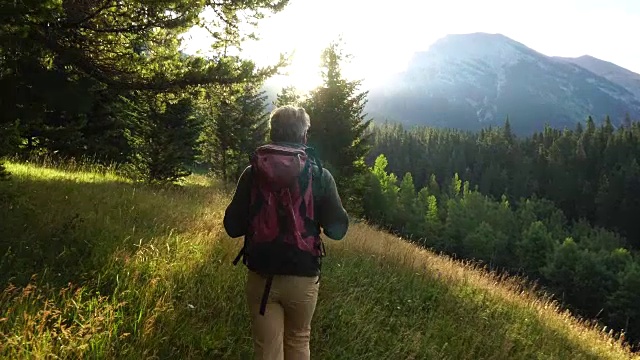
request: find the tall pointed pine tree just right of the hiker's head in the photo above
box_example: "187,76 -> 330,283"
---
303,42 -> 372,212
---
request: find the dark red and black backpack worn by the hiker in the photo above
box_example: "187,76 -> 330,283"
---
233,144 -> 324,314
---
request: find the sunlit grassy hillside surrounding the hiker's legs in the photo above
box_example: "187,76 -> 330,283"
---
0,163 -> 638,359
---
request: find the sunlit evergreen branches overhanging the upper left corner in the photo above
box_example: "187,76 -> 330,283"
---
0,0 -> 287,91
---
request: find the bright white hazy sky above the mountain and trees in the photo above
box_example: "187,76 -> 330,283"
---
182,0 -> 640,87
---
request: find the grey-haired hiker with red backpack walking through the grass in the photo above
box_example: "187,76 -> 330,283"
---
224,106 -> 349,360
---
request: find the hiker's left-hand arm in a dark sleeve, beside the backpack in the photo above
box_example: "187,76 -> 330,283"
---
223,166 -> 251,238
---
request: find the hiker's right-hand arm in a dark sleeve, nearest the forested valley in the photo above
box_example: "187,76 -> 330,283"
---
318,169 -> 349,240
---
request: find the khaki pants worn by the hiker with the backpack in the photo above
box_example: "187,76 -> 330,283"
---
246,271 -> 319,360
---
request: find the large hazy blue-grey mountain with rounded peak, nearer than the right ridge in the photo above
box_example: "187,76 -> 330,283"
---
367,33 -> 640,134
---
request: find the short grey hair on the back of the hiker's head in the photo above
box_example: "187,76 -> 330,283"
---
269,105 -> 311,143
